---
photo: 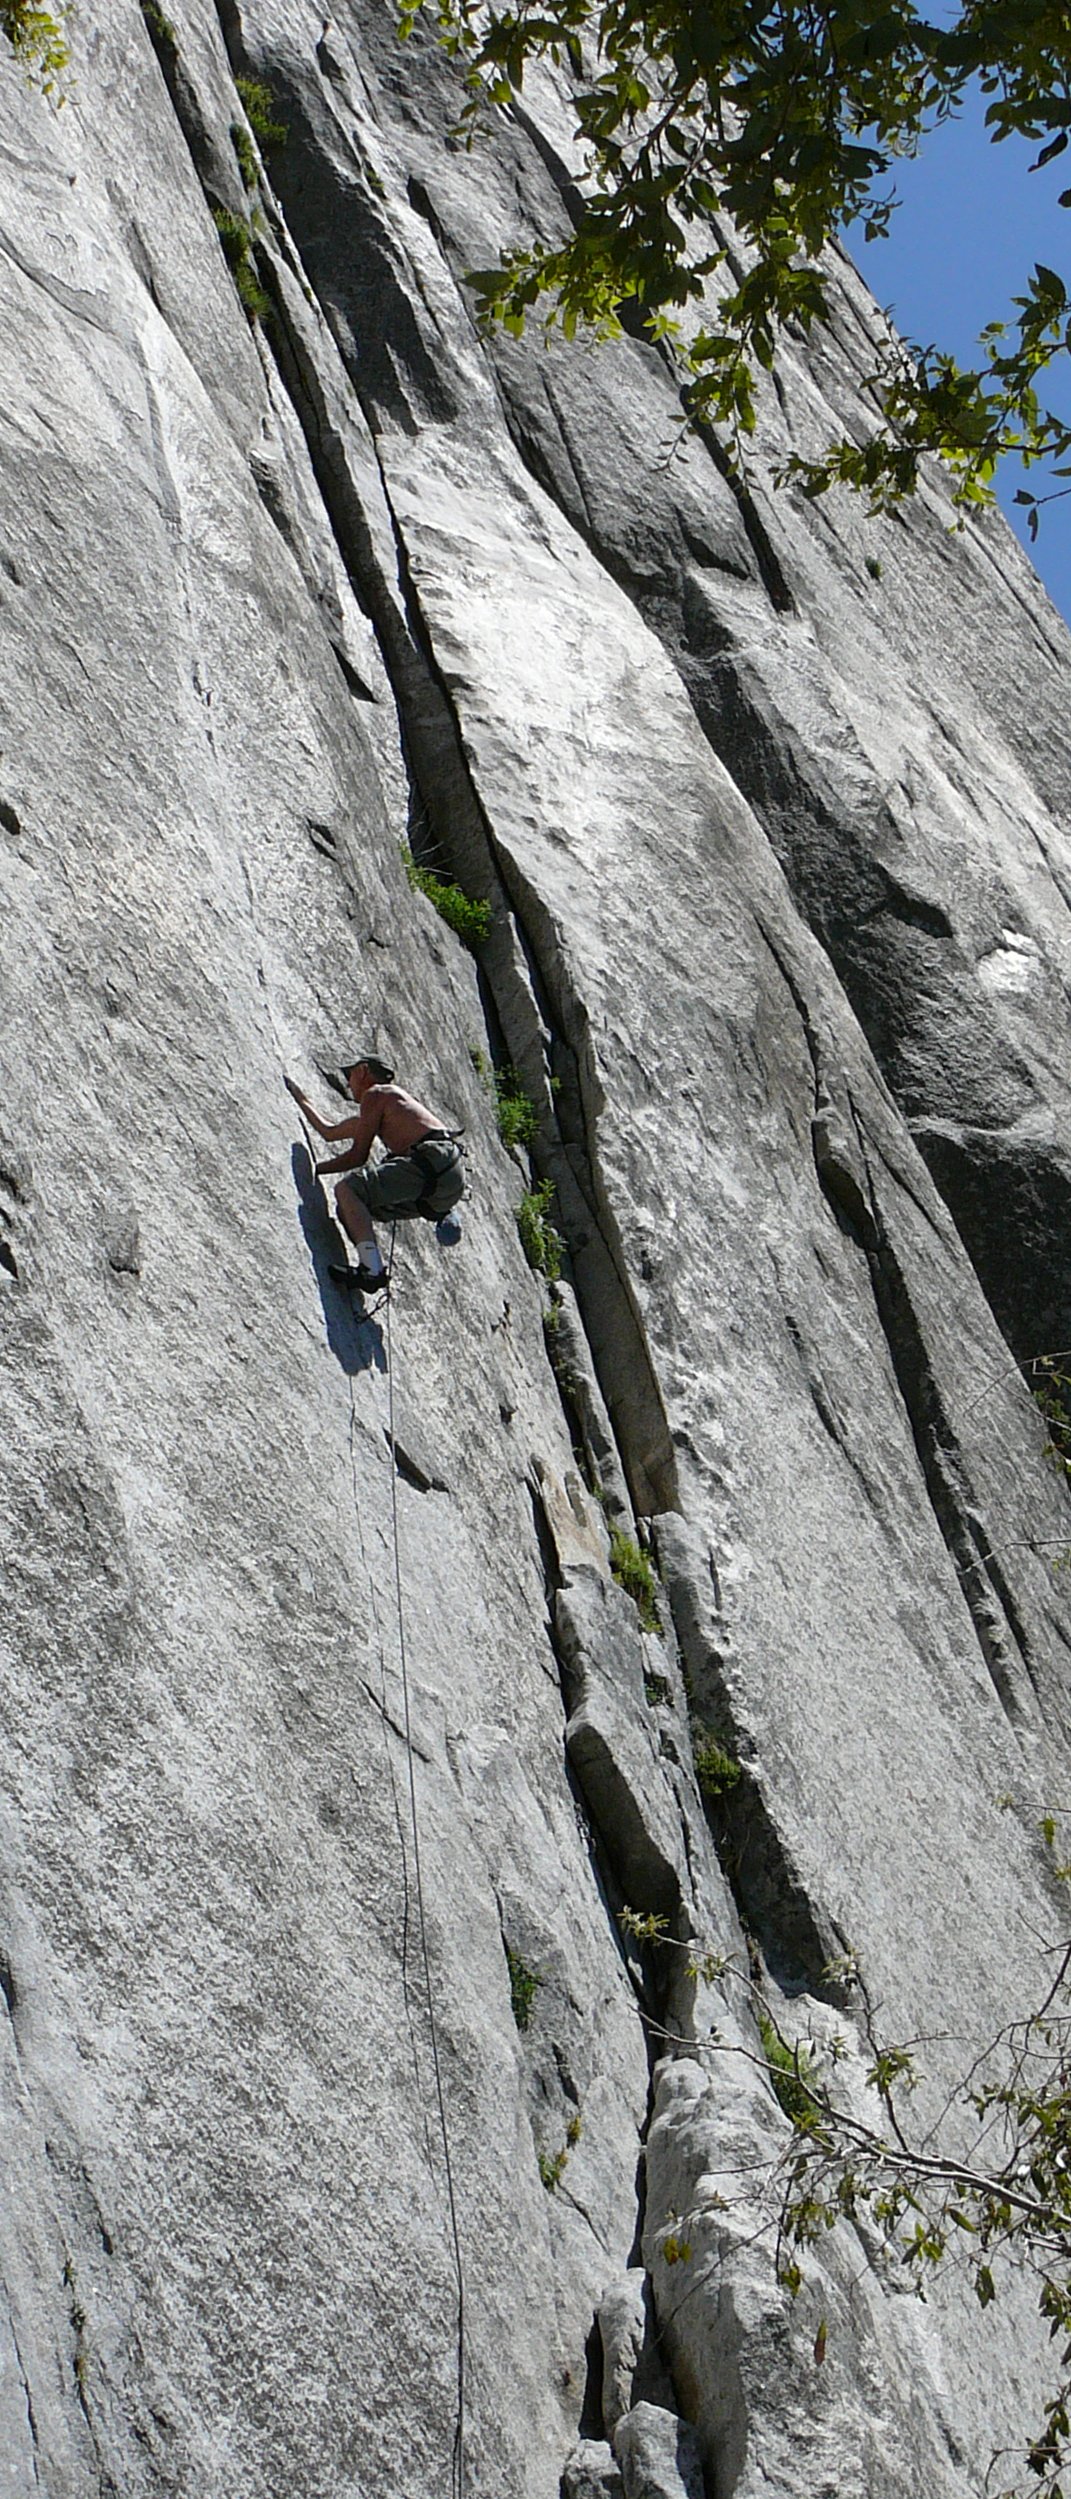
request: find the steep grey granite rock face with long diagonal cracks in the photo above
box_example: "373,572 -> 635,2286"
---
0,0 -> 1071,2499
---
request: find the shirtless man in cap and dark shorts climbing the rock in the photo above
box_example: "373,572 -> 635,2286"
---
282,1052 -> 464,1292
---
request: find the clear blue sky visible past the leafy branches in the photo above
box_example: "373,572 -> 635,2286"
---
844,97 -> 1071,620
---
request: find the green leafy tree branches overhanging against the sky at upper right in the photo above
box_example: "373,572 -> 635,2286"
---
399,0 -> 1071,527
